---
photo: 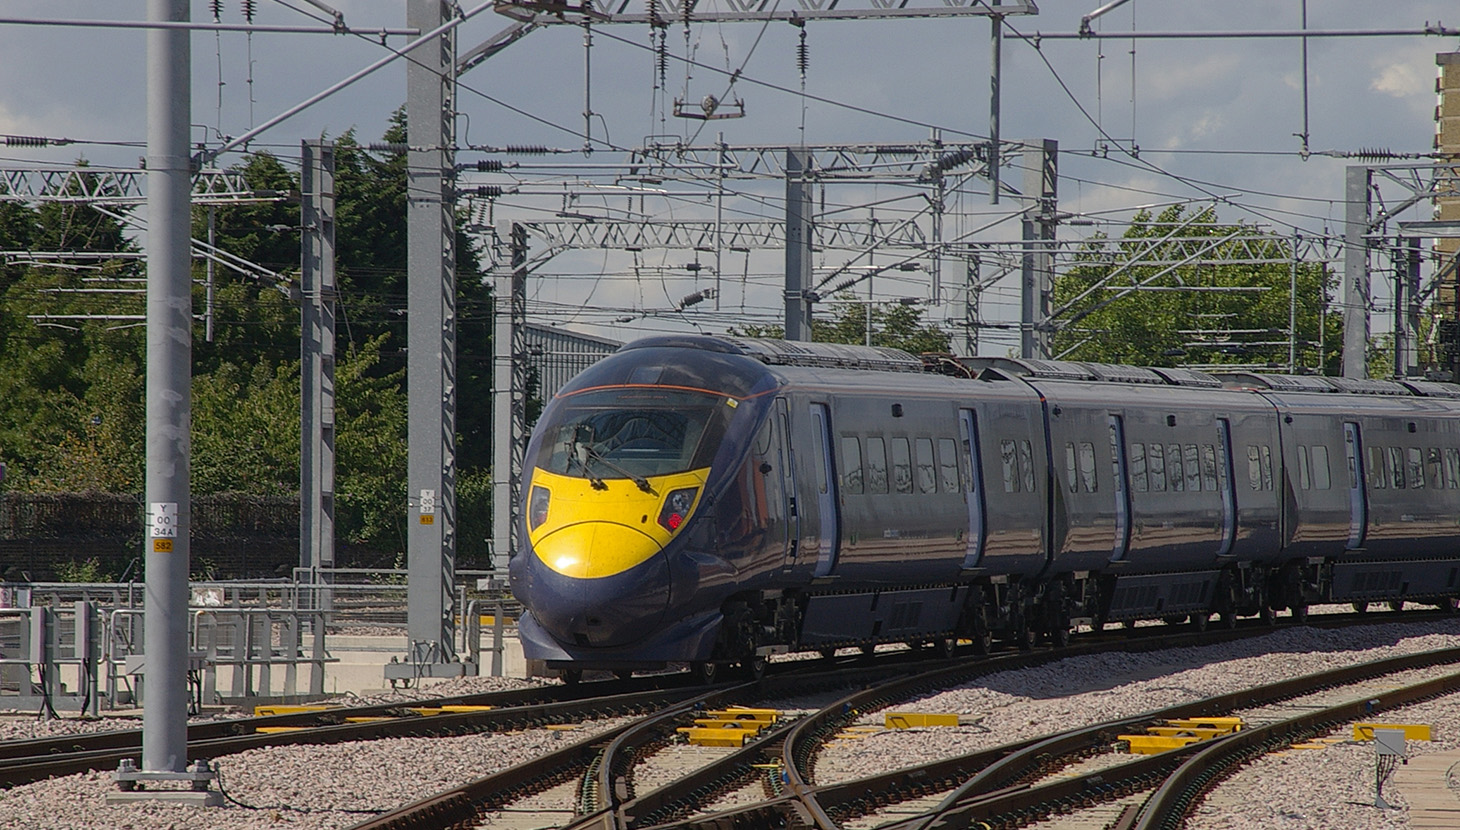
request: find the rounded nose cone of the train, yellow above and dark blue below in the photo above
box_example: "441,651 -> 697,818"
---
531,522 -> 669,647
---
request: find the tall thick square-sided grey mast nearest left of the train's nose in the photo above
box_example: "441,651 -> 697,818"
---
406,0 -> 456,674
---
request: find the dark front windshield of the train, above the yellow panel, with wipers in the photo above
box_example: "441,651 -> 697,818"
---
536,387 -> 731,481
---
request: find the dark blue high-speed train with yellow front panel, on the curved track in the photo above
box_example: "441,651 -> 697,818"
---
510,336 -> 1460,679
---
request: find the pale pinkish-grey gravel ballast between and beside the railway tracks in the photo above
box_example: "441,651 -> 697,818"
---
0,617 -> 1460,830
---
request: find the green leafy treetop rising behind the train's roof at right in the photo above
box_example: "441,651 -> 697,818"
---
1051,206 -> 1342,371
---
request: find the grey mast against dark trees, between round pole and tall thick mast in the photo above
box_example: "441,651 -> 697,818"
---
299,140 -> 337,628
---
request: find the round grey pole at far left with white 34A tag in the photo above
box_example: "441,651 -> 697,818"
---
142,0 -> 193,773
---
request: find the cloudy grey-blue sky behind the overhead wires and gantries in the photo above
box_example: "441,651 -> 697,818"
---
0,0 -> 1460,352
